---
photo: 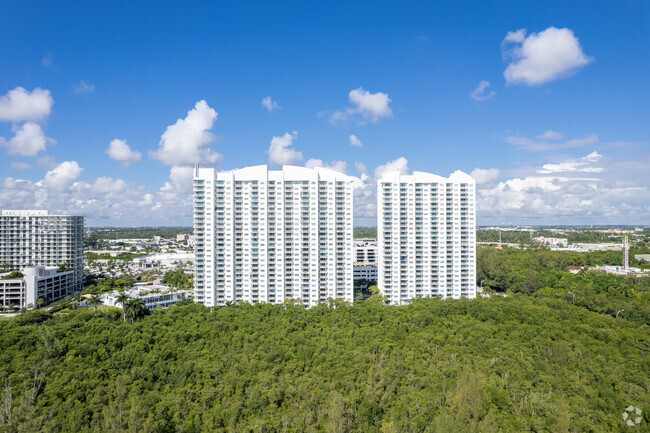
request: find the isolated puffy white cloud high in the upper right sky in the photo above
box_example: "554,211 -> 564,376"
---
502,27 -> 593,86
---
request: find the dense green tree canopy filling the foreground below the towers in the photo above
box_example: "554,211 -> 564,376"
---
0,296 -> 650,433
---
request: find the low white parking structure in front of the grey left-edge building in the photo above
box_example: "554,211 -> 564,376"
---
0,266 -> 75,310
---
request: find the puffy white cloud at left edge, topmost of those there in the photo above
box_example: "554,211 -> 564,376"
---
0,87 -> 54,122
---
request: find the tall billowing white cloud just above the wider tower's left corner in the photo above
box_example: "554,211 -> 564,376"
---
150,100 -> 223,165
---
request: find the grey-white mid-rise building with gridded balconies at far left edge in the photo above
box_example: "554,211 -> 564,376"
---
0,210 -> 84,290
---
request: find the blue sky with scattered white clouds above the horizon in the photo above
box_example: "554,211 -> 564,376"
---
0,0 -> 650,226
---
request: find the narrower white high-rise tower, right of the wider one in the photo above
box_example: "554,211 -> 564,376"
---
377,171 -> 476,305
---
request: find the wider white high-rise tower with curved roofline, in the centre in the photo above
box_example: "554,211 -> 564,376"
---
194,165 -> 353,307
